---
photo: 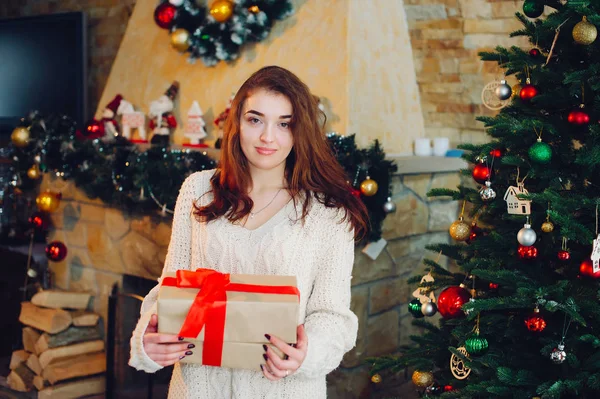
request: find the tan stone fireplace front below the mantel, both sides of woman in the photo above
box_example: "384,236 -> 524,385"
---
42,167 -> 460,398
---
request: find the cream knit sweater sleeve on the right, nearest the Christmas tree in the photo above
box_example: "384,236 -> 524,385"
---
296,208 -> 358,378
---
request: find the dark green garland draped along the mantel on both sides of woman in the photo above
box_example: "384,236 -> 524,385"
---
11,113 -> 397,241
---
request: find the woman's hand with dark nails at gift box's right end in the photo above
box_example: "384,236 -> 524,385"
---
260,324 -> 308,381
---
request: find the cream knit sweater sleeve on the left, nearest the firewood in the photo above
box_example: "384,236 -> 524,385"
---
129,172 -> 208,373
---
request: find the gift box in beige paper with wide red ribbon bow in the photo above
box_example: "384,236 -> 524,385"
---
158,269 -> 300,370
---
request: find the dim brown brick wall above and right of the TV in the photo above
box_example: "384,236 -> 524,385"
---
0,0 -> 136,119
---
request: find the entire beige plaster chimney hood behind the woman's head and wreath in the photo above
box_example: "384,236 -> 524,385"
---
96,0 -> 424,153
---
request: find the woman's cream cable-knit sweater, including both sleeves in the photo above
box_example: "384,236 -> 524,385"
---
129,171 -> 358,399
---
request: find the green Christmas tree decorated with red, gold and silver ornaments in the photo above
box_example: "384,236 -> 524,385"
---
371,0 -> 600,399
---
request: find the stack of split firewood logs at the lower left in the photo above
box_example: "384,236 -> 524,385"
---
7,291 -> 106,399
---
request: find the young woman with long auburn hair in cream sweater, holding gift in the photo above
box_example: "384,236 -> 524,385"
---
130,66 -> 367,399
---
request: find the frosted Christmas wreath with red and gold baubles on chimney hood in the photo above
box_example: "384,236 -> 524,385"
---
154,0 -> 294,66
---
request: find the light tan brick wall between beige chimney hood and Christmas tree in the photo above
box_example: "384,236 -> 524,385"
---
404,0 -> 528,145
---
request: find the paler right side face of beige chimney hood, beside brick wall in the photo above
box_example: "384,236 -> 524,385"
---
346,0 -> 424,155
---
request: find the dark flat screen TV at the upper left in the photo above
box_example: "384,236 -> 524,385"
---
0,12 -> 87,137
